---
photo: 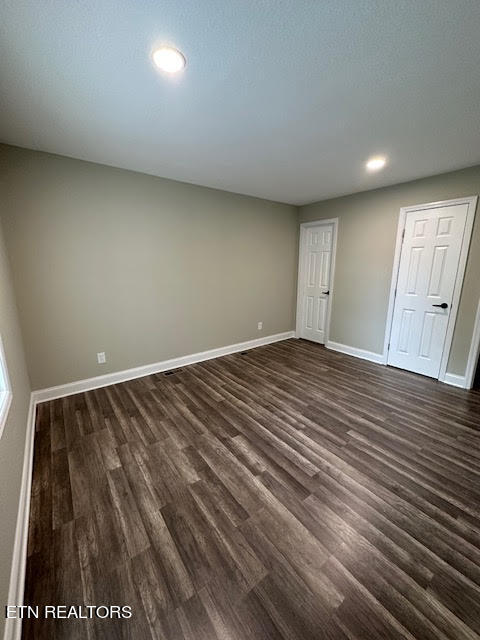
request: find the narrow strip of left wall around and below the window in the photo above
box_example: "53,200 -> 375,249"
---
0,220 -> 30,637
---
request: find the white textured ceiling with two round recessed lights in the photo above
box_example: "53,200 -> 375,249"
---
0,0 -> 480,204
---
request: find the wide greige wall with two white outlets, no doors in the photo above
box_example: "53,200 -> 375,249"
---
0,145 -> 298,389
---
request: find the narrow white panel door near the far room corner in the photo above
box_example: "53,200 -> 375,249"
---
298,223 -> 333,344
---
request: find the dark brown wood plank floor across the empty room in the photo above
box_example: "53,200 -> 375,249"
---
24,340 -> 480,640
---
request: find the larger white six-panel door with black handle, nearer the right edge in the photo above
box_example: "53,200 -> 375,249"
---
388,204 -> 468,378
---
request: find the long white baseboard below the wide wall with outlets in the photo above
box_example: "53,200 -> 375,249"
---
33,331 -> 295,403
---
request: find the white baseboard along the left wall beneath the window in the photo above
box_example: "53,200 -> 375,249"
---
3,393 -> 36,640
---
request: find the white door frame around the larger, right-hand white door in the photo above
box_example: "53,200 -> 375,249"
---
383,196 -> 478,382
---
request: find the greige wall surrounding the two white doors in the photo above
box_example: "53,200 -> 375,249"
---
299,166 -> 480,376
